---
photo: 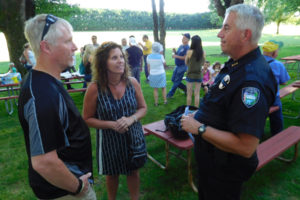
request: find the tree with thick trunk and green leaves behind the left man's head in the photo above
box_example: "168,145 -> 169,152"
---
0,0 -> 79,74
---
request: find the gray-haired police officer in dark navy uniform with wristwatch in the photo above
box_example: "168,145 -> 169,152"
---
181,4 -> 277,200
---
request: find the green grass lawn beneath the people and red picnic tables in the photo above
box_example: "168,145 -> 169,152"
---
0,30 -> 300,200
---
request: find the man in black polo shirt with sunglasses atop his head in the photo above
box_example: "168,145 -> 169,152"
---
18,14 -> 96,200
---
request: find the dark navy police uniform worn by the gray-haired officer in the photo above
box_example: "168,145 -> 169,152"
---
195,48 -> 277,199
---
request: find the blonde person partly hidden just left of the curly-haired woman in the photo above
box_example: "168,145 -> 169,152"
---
82,44 -> 95,88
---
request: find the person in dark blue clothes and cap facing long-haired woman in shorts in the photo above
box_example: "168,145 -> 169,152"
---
167,33 -> 191,98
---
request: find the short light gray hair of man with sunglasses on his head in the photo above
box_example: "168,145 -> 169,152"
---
24,14 -> 73,58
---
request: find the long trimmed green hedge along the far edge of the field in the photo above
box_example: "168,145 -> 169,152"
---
69,9 -> 220,30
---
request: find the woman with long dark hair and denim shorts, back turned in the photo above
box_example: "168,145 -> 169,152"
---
185,35 -> 205,107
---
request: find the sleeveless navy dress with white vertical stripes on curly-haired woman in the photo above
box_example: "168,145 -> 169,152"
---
97,83 -> 145,175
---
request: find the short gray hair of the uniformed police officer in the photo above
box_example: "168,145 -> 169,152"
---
225,4 -> 264,44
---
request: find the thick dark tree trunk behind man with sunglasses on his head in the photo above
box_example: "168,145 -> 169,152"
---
0,0 -> 34,74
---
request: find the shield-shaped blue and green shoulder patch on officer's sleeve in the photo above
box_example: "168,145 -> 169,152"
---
242,87 -> 260,108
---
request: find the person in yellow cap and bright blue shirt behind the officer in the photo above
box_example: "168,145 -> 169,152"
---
262,40 -> 290,136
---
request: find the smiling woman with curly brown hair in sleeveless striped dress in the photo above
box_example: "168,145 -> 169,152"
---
83,42 -> 147,200
